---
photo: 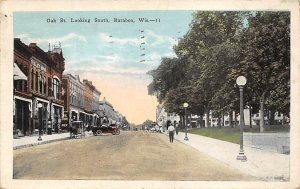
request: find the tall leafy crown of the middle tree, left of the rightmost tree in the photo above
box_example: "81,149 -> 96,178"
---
175,11 -> 246,127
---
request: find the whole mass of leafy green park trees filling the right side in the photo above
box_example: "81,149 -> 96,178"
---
148,11 -> 290,131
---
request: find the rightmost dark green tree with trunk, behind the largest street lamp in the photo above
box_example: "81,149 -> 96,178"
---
240,12 -> 290,132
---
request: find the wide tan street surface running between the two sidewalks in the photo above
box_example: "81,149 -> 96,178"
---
14,132 -> 256,180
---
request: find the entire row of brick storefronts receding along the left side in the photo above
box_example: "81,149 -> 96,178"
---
13,38 -> 122,136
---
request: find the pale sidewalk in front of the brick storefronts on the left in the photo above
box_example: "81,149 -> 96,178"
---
13,132 -> 93,150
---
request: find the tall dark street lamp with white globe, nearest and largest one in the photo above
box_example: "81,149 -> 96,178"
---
236,76 -> 247,161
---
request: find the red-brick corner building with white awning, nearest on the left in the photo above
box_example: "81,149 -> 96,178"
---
14,38 -> 65,135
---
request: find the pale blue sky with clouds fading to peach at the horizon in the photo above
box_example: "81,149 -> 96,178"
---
14,11 -> 193,124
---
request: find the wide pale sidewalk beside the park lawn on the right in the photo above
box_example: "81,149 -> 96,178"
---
165,132 -> 290,181
